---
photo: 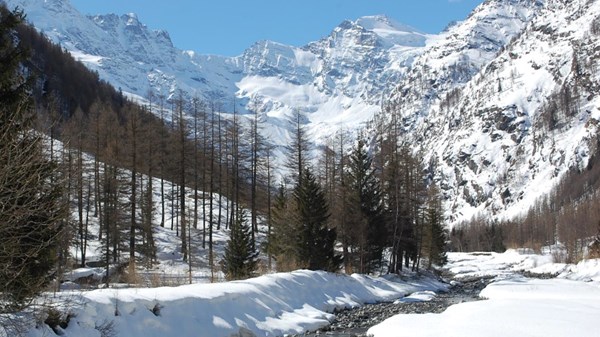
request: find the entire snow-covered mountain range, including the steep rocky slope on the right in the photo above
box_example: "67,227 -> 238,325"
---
6,0 -> 600,223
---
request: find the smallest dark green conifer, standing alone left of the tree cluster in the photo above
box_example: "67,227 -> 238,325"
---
223,210 -> 258,280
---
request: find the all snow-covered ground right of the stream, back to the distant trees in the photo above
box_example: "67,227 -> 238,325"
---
368,250 -> 600,337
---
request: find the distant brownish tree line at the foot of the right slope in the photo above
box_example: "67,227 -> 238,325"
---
450,143 -> 600,263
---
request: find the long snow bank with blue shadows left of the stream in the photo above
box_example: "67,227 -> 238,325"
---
29,270 -> 446,337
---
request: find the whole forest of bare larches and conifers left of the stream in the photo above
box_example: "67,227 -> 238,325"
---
0,7 -> 446,313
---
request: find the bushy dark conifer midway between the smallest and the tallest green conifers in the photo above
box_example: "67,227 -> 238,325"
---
291,168 -> 342,271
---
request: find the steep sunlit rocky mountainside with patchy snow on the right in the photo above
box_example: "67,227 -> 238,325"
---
384,0 -> 600,222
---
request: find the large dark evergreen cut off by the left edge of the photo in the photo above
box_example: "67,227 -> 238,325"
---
0,6 -> 67,313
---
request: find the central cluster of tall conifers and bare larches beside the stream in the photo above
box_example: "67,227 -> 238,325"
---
267,107 -> 447,273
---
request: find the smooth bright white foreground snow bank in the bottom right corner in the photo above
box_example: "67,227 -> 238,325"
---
368,278 -> 600,337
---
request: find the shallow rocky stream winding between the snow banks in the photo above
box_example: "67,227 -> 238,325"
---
294,277 -> 491,337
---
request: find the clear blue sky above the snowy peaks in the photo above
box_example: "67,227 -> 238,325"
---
71,0 -> 483,56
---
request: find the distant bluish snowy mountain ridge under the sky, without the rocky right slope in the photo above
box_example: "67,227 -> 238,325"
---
5,0 -> 431,144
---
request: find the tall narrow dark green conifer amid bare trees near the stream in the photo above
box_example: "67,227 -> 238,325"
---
346,140 -> 387,273
